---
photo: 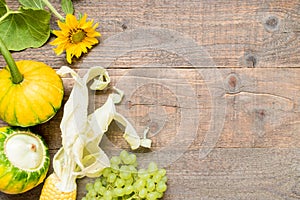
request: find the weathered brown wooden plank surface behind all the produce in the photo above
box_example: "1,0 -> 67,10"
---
0,0 -> 300,200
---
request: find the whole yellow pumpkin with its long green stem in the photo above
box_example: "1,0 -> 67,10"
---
0,40 -> 64,127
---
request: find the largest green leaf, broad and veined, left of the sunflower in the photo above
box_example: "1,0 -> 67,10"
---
0,8 -> 50,51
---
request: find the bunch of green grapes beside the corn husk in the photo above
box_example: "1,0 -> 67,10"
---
82,150 -> 168,200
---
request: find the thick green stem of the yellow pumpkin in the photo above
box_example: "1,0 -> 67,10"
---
0,38 -> 23,84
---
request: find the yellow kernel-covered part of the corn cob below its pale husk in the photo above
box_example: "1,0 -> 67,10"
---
40,173 -> 77,200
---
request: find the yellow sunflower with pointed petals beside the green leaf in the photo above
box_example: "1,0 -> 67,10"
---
50,14 -> 101,63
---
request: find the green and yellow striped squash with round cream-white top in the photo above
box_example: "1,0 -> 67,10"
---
0,126 -> 50,194
